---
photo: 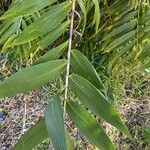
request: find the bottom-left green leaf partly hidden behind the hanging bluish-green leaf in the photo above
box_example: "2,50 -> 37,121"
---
13,119 -> 48,150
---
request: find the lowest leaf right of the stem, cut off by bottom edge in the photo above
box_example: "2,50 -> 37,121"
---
66,101 -> 115,150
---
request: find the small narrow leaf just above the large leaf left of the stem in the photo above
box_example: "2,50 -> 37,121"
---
34,41 -> 68,65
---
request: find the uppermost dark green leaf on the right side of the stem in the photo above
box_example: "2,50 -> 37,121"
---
71,50 -> 103,89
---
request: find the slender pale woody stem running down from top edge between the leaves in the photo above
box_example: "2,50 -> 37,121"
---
65,0 -> 76,100
